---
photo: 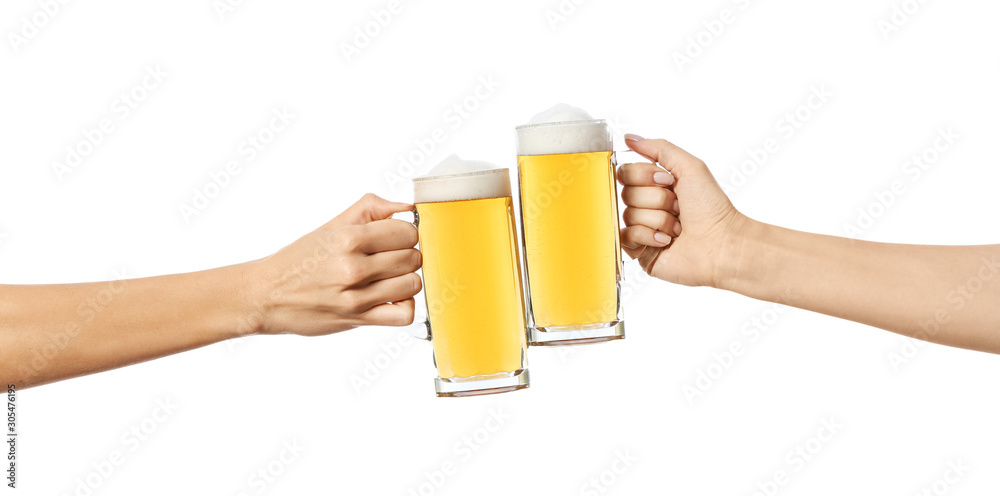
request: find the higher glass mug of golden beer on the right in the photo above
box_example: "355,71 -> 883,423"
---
515,119 -> 625,346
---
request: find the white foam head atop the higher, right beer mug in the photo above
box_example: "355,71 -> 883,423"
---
517,103 -> 611,155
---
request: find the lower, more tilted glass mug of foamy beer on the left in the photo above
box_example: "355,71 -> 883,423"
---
413,156 -> 529,396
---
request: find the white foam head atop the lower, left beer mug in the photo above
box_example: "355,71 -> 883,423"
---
413,155 -> 510,203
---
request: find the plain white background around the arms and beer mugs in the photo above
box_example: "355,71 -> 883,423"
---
0,0 -> 1000,495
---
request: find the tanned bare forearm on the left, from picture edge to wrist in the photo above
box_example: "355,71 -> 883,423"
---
0,265 -> 247,388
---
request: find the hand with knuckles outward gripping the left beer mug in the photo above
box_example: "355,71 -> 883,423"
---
244,193 -> 421,336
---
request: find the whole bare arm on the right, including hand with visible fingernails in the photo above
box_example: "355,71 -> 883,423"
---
619,134 -> 1000,353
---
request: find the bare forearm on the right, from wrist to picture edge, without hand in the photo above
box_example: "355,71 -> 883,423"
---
722,221 -> 1000,353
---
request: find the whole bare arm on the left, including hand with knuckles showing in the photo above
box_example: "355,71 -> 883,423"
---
0,195 -> 420,388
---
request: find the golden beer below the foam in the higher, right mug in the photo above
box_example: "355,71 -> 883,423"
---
517,152 -> 621,327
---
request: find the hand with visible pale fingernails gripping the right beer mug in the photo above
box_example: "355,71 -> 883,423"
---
618,134 -> 750,287
